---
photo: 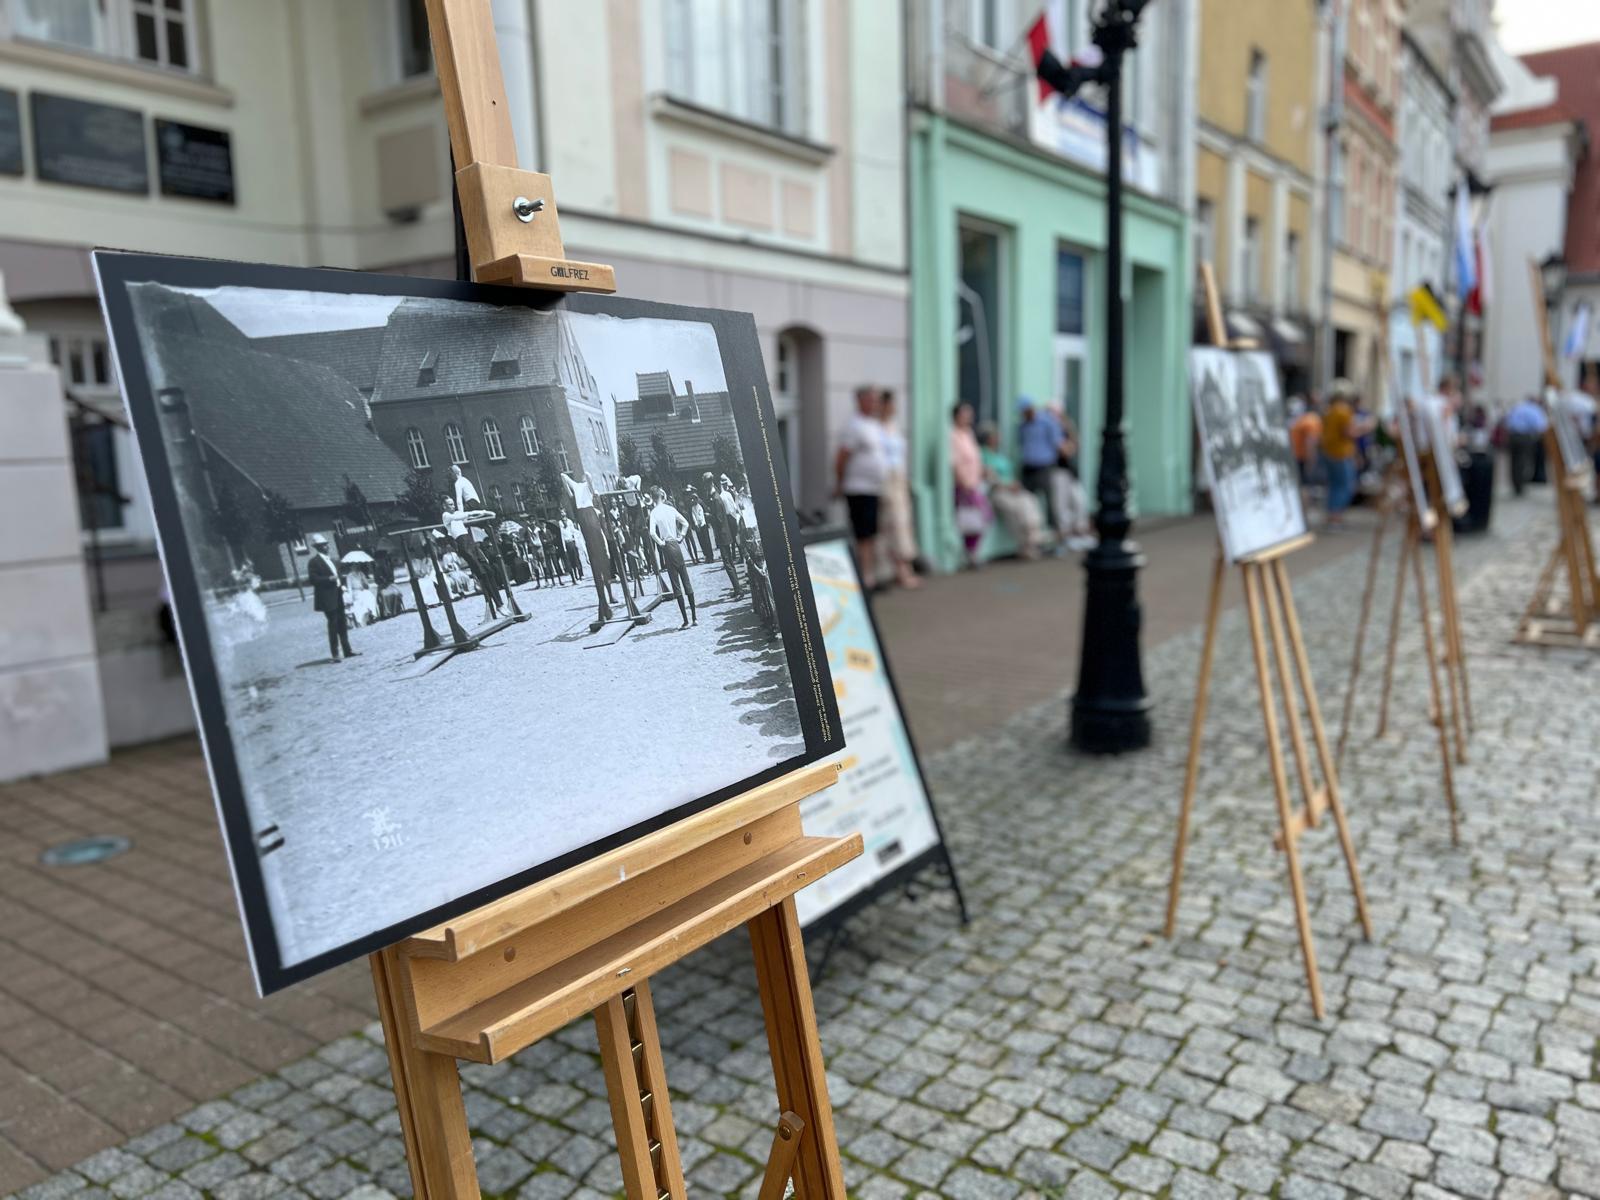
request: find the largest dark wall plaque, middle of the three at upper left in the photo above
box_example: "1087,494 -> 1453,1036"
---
29,91 -> 150,192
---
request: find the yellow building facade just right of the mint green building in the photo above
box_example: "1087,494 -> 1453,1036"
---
1194,0 -> 1322,390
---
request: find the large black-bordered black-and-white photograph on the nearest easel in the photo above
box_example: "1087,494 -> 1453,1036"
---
96,253 -> 842,990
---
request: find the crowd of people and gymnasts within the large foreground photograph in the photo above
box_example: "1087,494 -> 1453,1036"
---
306,454 -> 778,661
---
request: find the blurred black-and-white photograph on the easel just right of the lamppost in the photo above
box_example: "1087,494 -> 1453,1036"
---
1189,346 -> 1306,562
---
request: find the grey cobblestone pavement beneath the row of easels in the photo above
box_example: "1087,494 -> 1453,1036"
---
12,492 -> 1600,1200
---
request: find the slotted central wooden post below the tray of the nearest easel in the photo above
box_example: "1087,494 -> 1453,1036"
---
594,979 -> 685,1200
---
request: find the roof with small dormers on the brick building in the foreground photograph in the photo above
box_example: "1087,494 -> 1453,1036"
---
373,299 -> 598,405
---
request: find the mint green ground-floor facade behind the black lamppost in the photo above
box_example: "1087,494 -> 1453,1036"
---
909,109 -> 1194,570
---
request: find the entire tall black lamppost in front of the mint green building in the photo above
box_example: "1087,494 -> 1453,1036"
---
1038,0 -> 1150,754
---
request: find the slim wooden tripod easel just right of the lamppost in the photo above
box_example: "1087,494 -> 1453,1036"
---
1165,262 -> 1373,1019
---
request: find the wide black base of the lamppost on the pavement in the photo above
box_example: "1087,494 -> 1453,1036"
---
1070,538 -> 1150,754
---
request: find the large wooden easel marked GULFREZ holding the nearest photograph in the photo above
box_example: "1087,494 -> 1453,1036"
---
371,0 -> 862,1200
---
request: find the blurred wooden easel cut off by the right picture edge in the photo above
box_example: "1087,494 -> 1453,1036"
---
1514,259 -> 1600,650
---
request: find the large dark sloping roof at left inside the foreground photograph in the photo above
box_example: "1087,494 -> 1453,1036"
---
148,333 -> 406,509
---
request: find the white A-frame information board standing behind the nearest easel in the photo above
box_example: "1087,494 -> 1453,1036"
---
795,531 -> 965,925
